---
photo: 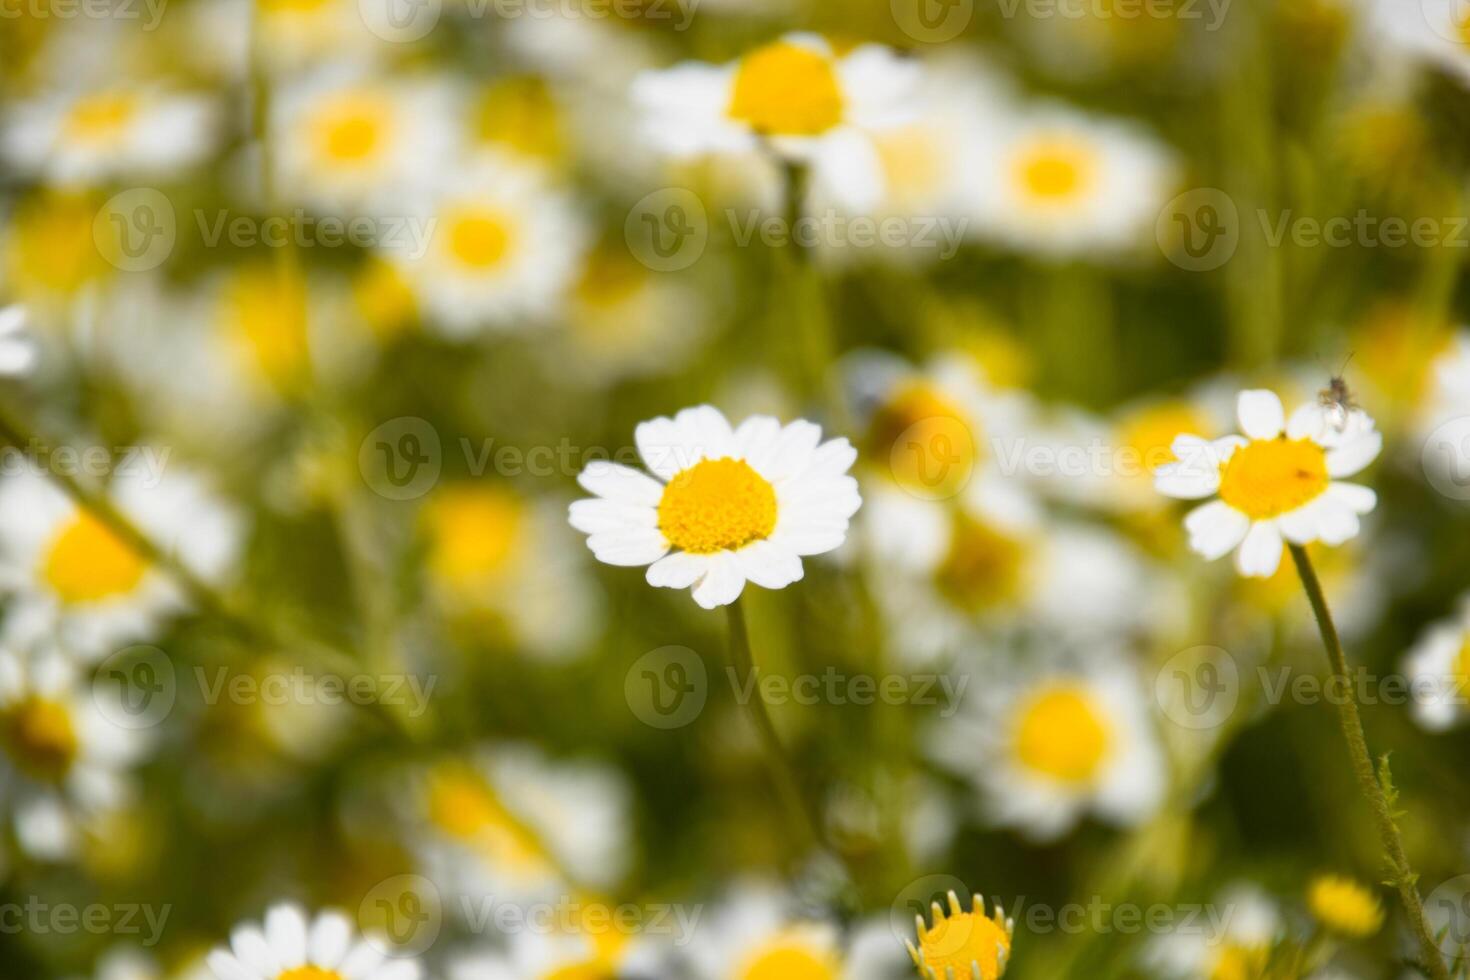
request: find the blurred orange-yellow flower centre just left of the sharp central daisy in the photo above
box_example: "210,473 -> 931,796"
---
423,486 -> 525,588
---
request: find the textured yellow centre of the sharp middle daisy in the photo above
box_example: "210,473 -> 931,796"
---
659,457 -> 776,554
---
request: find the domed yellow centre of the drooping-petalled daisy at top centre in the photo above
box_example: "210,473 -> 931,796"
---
729,41 -> 842,137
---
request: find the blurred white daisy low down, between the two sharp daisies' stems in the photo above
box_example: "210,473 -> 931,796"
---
929,658 -> 1166,840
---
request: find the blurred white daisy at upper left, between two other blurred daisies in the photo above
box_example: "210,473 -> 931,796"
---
272,69 -> 457,219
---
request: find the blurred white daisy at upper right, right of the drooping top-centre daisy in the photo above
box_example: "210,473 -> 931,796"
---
969,106 -> 1173,256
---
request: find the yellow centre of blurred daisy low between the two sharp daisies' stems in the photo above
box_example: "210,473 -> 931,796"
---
1016,686 -> 1113,785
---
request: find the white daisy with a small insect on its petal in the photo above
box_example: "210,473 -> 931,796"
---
1154,389 -> 1383,577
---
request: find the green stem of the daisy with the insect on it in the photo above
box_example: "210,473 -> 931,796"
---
1291,545 -> 1449,980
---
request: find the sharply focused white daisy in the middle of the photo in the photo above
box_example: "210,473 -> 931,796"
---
570,406 -> 861,608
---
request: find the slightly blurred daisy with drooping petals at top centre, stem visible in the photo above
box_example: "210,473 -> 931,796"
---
634,34 -> 920,207
